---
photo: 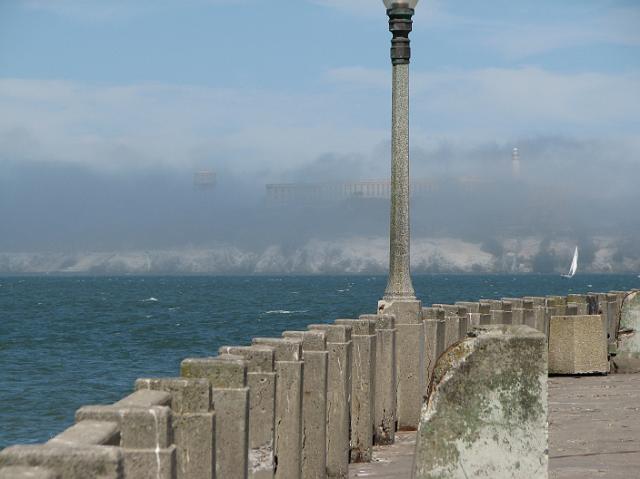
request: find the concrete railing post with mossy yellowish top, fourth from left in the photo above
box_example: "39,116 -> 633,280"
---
180,354 -> 249,479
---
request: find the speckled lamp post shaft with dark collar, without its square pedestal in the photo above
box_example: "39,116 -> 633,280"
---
383,0 -> 418,301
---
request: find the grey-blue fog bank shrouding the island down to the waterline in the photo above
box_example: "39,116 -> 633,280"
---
0,137 -> 640,273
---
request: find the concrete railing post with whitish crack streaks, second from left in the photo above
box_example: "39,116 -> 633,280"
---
76,403 -> 176,479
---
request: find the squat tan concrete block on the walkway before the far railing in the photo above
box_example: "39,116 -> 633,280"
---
549,315 -> 609,374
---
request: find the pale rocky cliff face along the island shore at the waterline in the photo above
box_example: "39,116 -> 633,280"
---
0,237 -> 640,274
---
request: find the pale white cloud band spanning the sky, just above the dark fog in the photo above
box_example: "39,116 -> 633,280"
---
0,63 -> 640,175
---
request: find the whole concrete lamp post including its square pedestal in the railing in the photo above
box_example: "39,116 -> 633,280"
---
378,0 -> 426,430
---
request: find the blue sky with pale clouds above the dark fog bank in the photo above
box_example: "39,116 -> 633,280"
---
0,0 -> 640,181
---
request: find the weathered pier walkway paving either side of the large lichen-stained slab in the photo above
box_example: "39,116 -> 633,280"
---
349,374 -> 640,479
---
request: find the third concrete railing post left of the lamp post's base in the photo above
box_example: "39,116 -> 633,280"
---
309,324 -> 352,479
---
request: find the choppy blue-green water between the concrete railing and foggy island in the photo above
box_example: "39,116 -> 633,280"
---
0,275 -> 640,448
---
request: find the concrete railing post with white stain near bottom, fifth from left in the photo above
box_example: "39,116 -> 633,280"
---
219,346 -> 276,479
